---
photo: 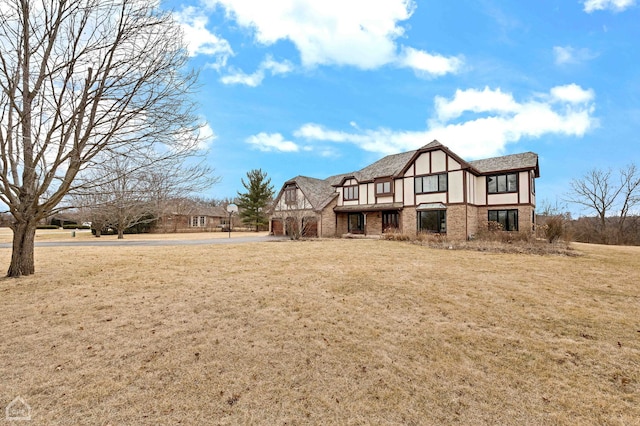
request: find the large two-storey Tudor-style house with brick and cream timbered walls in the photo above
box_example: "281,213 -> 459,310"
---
270,141 -> 540,239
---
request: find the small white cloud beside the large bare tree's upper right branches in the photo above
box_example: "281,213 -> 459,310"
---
174,6 -> 233,62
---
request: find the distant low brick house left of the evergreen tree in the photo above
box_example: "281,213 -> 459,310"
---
153,200 -> 229,232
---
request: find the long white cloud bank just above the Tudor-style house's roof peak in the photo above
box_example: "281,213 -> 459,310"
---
294,84 -> 597,159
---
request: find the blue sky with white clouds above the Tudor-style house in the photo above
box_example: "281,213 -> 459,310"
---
161,0 -> 640,211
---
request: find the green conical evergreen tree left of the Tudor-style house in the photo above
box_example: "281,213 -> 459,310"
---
236,169 -> 274,232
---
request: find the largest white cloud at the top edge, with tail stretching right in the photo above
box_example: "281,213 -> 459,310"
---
205,0 -> 462,76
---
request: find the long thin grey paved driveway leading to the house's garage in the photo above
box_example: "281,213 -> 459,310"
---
0,236 -> 287,248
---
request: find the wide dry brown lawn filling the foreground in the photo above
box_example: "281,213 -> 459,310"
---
0,240 -> 640,425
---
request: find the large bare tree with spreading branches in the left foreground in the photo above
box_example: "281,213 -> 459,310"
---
0,0 -> 201,277
